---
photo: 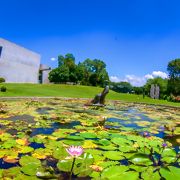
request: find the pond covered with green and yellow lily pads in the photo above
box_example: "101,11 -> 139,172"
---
0,98 -> 180,180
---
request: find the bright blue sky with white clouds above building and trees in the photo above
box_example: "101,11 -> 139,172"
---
0,0 -> 180,85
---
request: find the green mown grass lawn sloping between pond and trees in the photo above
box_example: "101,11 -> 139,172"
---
0,83 -> 180,107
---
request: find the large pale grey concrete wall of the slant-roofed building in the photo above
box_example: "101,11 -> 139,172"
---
0,38 -> 40,83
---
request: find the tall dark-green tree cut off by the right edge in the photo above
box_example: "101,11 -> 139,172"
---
167,59 -> 180,96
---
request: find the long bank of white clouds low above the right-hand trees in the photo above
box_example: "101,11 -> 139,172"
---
110,71 -> 168,86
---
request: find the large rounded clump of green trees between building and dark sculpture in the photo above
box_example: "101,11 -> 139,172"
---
49,54 -> 109,86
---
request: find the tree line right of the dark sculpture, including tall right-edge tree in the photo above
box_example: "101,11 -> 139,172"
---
110,59 -> 180,101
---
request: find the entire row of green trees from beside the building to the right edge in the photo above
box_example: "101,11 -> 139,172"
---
49,53 -> 180,100
